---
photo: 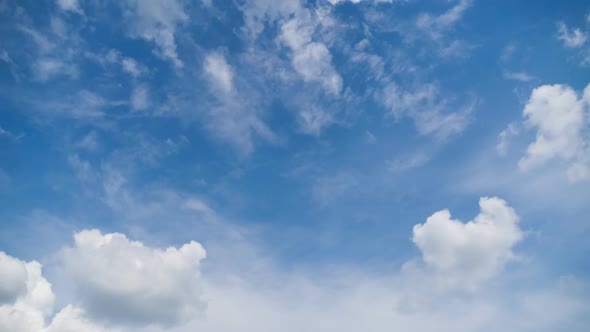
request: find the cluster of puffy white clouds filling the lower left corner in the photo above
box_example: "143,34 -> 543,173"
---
0,230 -> 206,332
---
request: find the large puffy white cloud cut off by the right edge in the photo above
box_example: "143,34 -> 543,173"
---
518,84 -> 590,181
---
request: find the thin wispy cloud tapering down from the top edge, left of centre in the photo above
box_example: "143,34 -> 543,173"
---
121,0 -> 189,68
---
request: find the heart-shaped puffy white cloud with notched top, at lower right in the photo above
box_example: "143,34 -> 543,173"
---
412,197 -> 522,290
